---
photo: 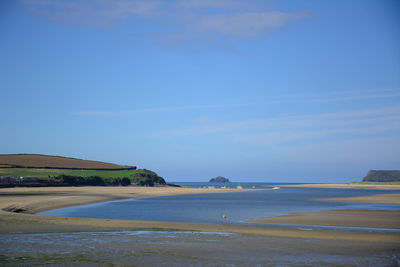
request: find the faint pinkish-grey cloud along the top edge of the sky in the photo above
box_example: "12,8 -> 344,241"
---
20,0 -> 312,43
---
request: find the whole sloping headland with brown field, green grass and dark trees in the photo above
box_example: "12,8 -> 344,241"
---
0,154 -> 166,186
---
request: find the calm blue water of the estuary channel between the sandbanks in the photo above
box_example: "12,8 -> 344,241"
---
40,184 -> 400,226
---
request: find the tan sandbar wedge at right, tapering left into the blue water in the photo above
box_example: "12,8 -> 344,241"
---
249,210 -> 400,229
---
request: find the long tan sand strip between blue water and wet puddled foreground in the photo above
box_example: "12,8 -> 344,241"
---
0,211 -> 400,244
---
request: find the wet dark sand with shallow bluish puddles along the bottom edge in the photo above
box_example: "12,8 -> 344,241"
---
0,231 -> 400,267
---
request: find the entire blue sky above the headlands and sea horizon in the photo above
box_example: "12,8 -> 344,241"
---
0,0 -> 400,182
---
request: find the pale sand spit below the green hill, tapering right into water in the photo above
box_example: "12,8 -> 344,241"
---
0,186 -> 247,214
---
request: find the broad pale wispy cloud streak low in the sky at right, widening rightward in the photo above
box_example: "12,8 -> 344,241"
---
161,107 -> 400,137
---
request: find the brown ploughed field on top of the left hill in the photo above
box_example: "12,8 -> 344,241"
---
0,154 -> 131,169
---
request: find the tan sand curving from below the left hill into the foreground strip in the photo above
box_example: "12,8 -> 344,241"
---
0,187 -> 400,243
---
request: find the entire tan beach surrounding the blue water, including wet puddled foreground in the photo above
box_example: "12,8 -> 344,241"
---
0,187 -> 400,266
